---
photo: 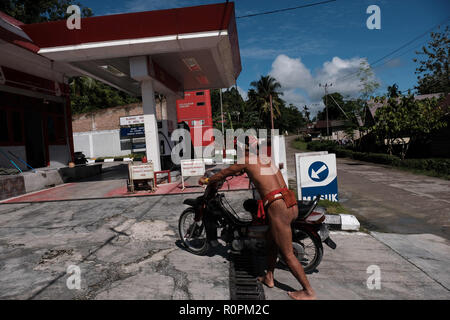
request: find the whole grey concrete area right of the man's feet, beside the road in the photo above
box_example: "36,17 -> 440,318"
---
264,231 -> 450,300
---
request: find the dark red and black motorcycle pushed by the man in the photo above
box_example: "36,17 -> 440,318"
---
178,171 -> 336,272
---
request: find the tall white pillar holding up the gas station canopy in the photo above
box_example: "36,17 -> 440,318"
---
141,79 -> 161,171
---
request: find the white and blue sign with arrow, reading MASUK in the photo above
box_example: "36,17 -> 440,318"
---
295,152 -> 338,201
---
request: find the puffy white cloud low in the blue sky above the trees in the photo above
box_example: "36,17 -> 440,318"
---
269,54 -> 374,114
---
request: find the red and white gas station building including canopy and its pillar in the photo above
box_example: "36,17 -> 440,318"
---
0,2 -> 241,170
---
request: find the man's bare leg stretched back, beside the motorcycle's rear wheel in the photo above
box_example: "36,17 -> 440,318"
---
268,201 -> 316,300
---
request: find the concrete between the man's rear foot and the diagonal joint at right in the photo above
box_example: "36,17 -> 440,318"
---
264,232 -> 450,300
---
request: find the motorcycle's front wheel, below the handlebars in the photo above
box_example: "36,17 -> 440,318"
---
178,208 -> 209,256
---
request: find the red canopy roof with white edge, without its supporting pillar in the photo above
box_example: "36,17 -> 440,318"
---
20,3 -> 241,96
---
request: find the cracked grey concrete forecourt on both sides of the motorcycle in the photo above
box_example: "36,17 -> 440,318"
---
0,191 -> 450,300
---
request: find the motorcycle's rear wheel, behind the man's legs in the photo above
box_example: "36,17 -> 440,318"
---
278,230 -> 323,273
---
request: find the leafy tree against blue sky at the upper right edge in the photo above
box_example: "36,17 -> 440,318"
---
413,26 -> 450,94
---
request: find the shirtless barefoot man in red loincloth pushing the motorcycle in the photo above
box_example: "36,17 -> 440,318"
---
199,140 -> 316,300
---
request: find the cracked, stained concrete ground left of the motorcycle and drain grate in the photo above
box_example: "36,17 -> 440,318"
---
0,192 -> 251,300
